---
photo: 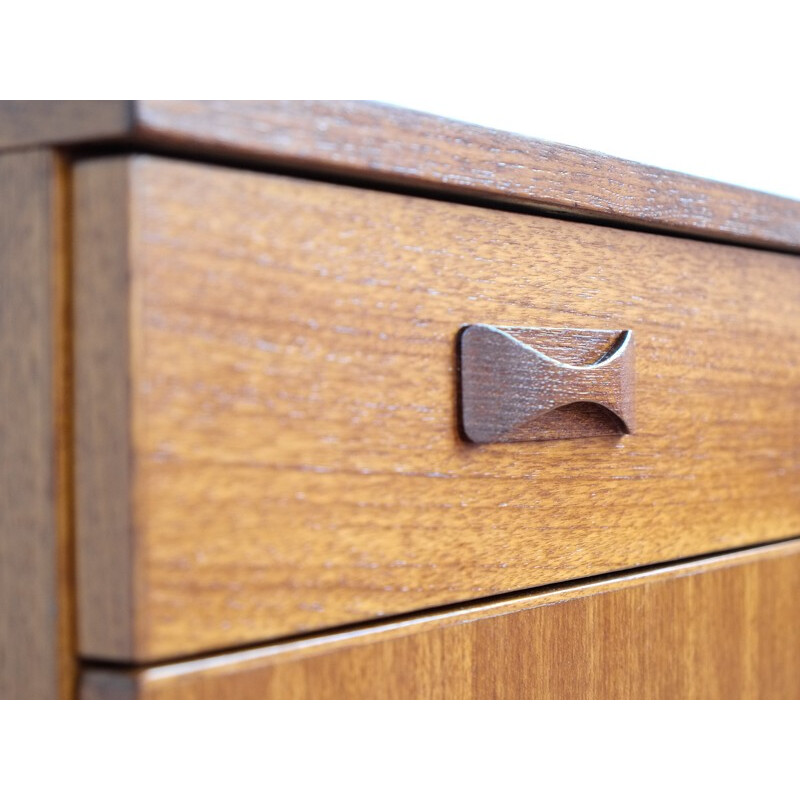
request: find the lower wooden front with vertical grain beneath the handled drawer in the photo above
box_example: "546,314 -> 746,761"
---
82,541 -> 800,699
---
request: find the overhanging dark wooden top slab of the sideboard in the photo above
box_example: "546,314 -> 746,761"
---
0,100 -> 800,252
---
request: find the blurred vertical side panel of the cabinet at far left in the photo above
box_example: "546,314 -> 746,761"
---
0,151 -> 75,699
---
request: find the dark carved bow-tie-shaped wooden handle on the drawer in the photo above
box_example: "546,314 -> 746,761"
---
460,325 -> 634,444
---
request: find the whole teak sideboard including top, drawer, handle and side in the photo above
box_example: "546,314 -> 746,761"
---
0,101 -> 800,698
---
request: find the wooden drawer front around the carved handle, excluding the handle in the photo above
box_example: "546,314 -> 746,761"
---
75,156 -> 800,660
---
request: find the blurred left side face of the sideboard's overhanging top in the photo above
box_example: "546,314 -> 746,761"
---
0,100 -> 133,150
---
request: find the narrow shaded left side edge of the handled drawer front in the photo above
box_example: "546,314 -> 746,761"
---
74,159 -> 133,658
